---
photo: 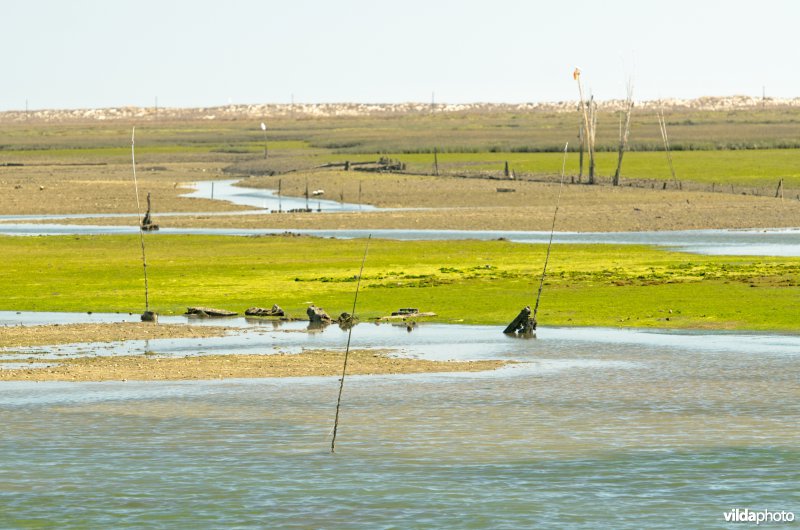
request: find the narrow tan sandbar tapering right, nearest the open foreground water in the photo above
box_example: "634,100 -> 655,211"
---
0,350 -> 507,381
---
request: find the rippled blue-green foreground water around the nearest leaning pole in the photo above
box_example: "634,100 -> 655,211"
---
0,314 -> 800,529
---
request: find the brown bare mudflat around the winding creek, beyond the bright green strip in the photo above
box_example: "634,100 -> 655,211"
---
7,167 -> 800,232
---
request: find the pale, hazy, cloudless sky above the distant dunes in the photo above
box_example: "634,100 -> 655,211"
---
0,0 -> 800,110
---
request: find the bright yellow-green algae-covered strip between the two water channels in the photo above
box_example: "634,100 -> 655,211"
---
0,235 -> 800,331
